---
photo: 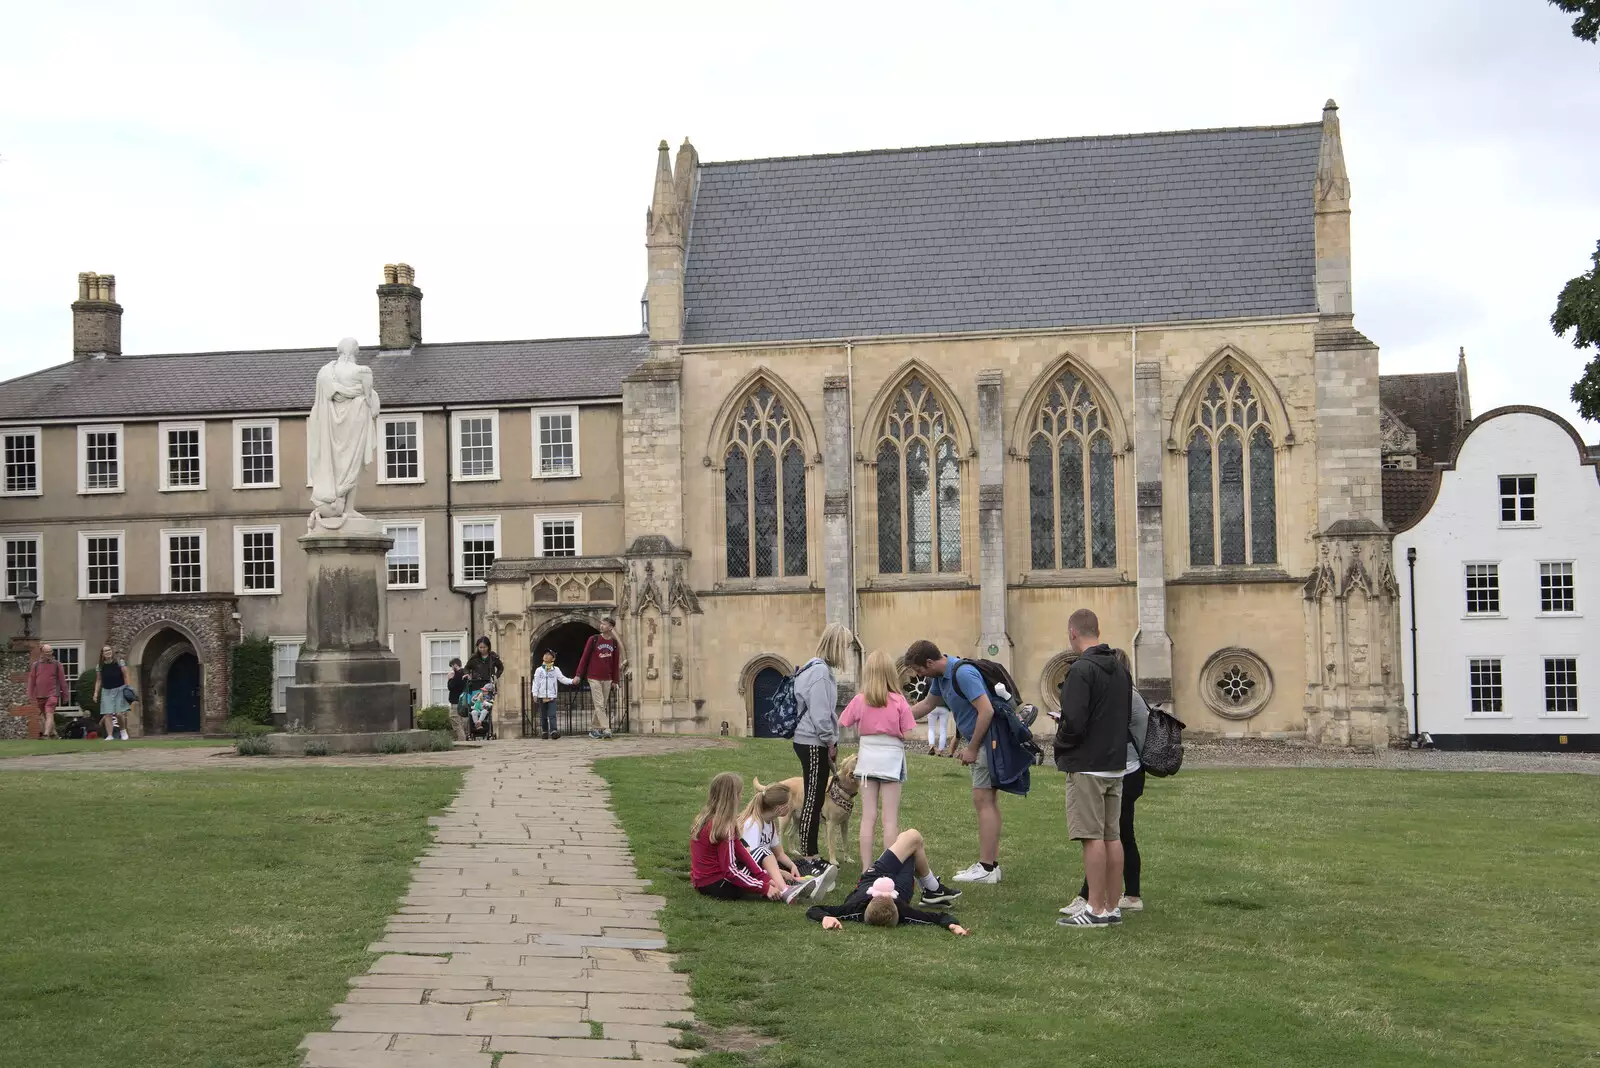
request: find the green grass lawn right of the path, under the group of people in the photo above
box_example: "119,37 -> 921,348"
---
598,742 -> 1600,1068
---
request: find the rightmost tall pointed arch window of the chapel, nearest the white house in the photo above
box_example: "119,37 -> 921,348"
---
1186,360 -> 1278,568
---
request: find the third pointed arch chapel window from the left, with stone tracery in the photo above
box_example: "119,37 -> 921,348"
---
1027,371 -> 1117,571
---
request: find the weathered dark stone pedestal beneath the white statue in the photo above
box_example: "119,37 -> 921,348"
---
285,521 -> 411,734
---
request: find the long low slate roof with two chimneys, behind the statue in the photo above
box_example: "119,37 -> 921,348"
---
0,334 -> 650,422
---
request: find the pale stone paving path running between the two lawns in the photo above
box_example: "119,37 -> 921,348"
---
302,739 -> 715,1068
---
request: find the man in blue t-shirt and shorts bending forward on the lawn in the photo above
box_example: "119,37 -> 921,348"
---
906,640 -> 1000,883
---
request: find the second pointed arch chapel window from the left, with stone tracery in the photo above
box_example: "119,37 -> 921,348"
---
877,376 -> 962,574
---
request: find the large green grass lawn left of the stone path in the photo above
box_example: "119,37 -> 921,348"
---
0,767 -> 461,1068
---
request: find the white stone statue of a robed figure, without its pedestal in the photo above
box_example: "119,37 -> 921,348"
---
306,337 -> 378,532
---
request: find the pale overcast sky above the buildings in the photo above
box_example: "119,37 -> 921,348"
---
0,0 -> 1600,441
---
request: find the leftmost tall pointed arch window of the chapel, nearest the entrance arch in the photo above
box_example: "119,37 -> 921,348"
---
723,384 -> 808,579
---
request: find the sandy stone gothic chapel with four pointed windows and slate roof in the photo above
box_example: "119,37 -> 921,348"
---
488,101 -> 1405,745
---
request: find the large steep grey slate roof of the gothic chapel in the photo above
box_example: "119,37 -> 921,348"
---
685,123 -> 1322,344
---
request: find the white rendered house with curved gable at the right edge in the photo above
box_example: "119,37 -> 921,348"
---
1394,406 -> 1600,751
